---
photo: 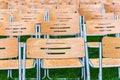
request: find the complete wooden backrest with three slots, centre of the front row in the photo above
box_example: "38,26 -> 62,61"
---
27,38 -> 85,59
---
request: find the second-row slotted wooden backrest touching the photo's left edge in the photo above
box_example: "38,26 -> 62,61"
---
0,22 -> 35,36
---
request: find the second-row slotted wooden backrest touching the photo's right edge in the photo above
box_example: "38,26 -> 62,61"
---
86,20 -> 120,35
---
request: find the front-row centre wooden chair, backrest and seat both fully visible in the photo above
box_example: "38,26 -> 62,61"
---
26,38 -> 85,80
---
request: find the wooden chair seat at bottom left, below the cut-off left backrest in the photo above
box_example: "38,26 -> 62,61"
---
0,59 -> 34,70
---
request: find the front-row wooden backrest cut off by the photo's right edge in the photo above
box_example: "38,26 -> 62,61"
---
102,37 -> 120,58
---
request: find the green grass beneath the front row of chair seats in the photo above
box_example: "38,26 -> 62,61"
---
0,68 -> 120,80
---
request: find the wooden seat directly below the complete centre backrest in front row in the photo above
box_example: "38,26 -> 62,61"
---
42,59 -> 83,69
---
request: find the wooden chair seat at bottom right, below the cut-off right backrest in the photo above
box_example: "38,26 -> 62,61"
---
90,58 -> 120,68
